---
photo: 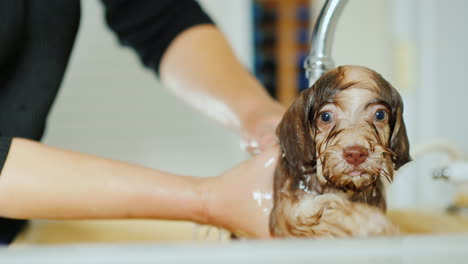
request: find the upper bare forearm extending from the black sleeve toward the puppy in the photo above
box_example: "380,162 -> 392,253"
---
160,25 -> 283,130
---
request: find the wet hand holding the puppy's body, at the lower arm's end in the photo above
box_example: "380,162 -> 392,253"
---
200,145 -> 279,238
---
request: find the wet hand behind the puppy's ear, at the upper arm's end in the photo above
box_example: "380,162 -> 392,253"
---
241,102 -> 285,155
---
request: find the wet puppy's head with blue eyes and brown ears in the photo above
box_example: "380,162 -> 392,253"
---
277,66 -> 411,191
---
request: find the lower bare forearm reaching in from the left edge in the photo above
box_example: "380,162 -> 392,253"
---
0,138 -> 205,223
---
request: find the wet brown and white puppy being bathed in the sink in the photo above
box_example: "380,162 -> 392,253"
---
270,66 -> 411,237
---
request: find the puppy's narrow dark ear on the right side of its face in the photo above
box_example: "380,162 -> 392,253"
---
390,87 -> 411,170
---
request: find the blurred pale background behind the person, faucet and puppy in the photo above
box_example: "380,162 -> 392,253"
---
44,0 -> 468,210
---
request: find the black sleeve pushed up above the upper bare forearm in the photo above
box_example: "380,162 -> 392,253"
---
102,0 -> 213,74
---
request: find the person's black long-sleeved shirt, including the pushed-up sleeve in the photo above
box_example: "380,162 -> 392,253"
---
0,0 -> 212,243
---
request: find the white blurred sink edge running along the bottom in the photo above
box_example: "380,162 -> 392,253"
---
0,235 -> 468,264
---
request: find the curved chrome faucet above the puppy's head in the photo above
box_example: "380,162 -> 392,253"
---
304,0 -> 348,87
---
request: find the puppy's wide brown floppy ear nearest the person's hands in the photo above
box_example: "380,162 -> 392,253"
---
276,88 -> 316,172
